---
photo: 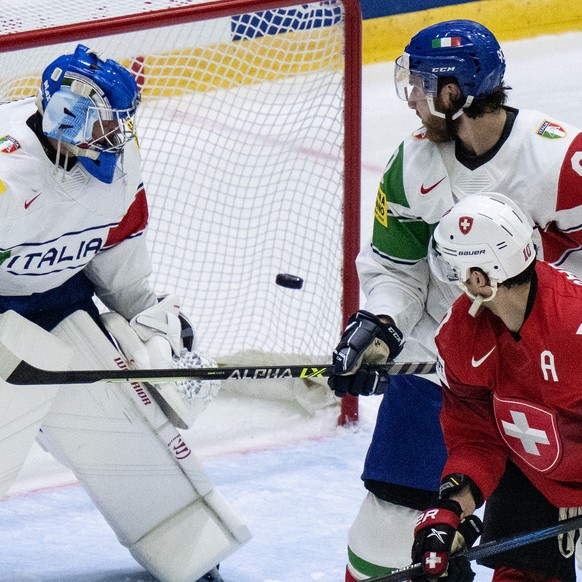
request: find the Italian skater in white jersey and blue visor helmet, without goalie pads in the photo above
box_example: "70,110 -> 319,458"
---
330,20 -> 582,582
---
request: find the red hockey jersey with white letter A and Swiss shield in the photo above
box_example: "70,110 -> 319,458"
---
436,262 -> 582,507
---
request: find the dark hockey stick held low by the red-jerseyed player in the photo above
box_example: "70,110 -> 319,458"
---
366,515 -> 582,582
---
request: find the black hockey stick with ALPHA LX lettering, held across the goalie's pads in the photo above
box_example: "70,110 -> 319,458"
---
0,358 -> 436,385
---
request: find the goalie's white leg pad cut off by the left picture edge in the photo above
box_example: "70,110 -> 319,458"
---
0,311 -> 72,498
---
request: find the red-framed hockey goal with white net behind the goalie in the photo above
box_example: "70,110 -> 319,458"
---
0,0 -> 361,423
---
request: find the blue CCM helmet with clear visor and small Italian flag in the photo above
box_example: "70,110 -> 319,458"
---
394,20 -> 505,117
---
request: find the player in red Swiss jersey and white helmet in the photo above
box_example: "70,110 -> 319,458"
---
412,193 -> 582,582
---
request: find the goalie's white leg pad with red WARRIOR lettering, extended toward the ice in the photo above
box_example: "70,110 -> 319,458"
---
42,312 -> 250,582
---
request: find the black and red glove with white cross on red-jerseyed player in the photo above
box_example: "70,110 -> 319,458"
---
412,499 -> 483,582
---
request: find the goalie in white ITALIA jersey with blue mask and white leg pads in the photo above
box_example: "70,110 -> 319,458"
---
0,45 -> 248,582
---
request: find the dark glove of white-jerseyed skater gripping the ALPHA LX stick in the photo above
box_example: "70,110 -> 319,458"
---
328,310 -> 404,396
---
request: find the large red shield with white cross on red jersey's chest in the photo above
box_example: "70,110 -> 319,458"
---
493,396 -> 562,473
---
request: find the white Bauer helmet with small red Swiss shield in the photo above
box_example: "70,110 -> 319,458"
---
428,192 -> 536,288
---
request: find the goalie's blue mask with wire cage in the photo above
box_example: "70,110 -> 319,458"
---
37,44 -> 140,184
